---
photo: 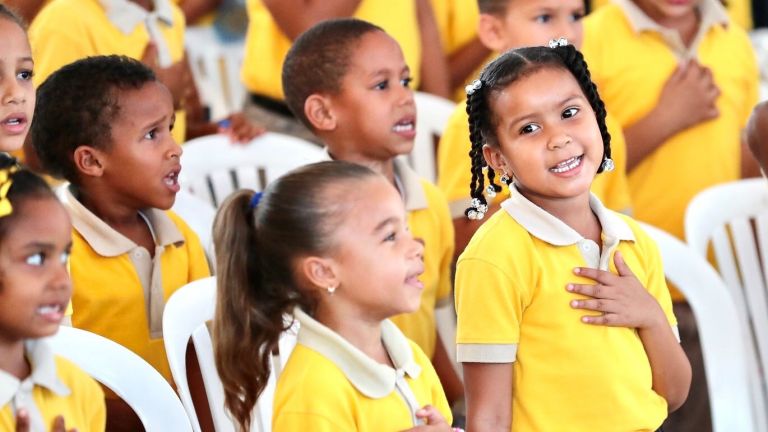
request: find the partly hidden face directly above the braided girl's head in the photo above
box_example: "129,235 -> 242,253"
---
490,0 -> 584,51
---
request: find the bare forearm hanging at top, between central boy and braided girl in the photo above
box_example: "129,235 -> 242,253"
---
416,0 -> 451,98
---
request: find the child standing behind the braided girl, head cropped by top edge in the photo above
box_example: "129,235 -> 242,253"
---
437,0 -> 631,255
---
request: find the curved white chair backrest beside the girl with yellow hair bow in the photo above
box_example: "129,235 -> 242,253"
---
50,326 -> 192,432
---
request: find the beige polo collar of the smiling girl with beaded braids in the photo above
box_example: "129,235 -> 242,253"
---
501,187 -> 635,246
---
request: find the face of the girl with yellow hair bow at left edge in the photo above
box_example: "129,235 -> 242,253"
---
0,198 -> 72,342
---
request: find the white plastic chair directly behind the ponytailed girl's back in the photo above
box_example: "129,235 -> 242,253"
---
163,277 -> 296,432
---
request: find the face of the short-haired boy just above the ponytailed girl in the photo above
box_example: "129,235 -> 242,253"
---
329,31 -> 416,162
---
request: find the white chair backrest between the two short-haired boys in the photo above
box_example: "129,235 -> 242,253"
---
181,133 -> 327,207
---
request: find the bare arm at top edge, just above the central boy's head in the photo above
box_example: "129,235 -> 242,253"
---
264,0 -> 361,40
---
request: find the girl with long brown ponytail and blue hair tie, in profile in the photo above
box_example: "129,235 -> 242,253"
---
213,162 -> 451,432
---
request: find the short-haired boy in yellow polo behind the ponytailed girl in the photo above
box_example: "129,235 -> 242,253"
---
283,18 -> 461,402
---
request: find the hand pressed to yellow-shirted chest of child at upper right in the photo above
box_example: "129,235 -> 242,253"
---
657,59 -> 720,133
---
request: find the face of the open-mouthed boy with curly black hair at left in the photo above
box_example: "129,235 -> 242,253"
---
100,82 -> 182,210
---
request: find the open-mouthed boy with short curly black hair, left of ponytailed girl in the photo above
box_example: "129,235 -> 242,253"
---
30,56 -> 209,430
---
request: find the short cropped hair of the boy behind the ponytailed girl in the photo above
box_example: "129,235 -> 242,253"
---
282,18 -> 384,130
